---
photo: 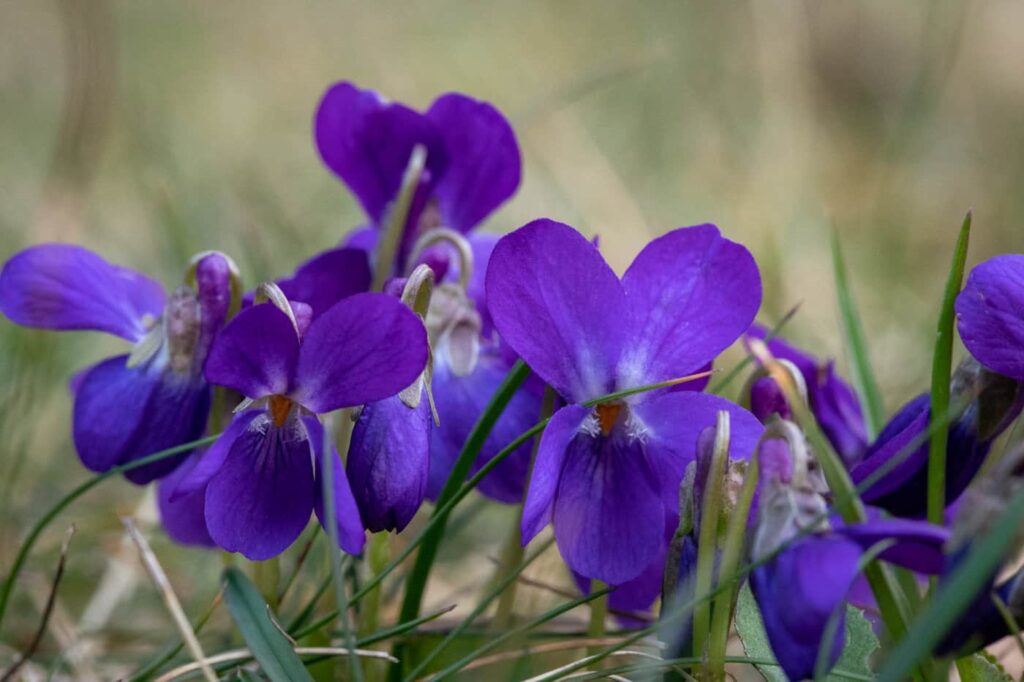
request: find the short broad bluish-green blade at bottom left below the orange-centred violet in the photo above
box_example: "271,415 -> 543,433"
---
223,566 -> 312,682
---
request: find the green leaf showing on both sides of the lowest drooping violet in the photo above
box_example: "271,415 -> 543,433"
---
736,585 -> 879,682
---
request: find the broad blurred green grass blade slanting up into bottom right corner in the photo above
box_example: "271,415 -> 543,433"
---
879,491 -> 1024,682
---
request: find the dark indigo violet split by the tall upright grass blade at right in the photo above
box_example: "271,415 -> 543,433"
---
850,357 -> 1024,518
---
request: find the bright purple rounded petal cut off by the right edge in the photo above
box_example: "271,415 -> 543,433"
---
956,254 -> 1024,381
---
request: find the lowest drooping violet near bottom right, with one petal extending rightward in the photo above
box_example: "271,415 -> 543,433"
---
751,427 -> 948,680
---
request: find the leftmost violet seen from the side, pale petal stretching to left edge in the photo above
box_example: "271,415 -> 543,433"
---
0,244 -> 232,483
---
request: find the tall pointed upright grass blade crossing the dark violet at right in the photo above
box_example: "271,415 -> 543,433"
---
928,206 -> 971,525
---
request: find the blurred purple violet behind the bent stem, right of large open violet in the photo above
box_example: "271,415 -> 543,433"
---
748,325 -> 867,467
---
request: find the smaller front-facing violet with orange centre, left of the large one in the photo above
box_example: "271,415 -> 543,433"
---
177,294 -> 427,560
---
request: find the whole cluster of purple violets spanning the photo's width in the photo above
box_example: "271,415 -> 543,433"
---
6,78 -> 1024,679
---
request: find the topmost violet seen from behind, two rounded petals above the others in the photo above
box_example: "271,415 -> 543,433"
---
314,83 -> 520,276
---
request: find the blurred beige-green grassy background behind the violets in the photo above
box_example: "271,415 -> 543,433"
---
0,0 -> 1024,675
